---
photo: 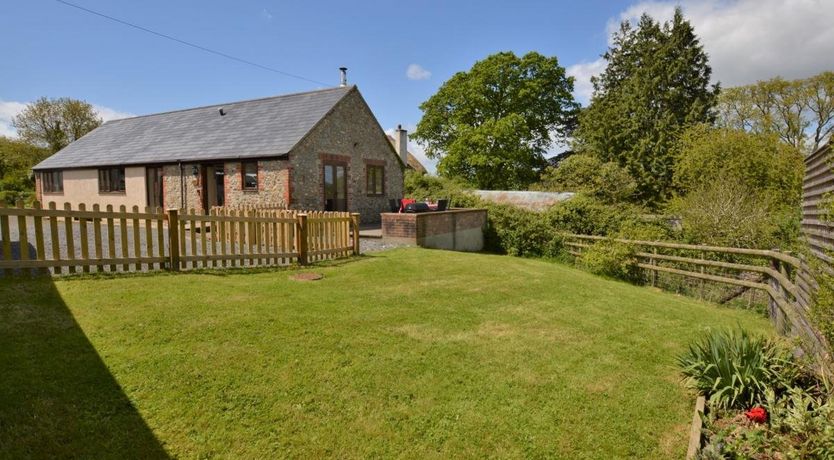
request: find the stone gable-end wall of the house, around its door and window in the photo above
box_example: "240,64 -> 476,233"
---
290,90 -> 403,222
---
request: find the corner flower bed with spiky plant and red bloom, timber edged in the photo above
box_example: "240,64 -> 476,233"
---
678,331 -> 834,459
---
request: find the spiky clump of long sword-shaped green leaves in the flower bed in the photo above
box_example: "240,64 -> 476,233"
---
678,330 -> 800,409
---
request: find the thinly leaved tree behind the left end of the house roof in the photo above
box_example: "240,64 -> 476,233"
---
12,97 -> 101,153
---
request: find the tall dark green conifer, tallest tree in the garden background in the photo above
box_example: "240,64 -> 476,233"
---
577,8 -> 718,206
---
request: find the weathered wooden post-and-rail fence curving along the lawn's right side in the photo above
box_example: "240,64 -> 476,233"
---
564,234 -> 834,375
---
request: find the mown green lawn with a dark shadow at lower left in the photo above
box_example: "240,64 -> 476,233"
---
0,249 -> 769,458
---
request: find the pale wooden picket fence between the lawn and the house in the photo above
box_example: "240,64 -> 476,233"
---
0,202 -> 359,274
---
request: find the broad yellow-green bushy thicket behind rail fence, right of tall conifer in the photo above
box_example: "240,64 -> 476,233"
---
669,125 -> 803,248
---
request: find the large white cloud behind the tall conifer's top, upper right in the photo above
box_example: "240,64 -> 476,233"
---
608,0 -> 834,87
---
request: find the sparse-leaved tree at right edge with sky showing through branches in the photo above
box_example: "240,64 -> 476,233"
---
718,72 -> 834,152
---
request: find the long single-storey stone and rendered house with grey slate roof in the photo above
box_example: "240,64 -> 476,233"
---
33,84 -> 410,222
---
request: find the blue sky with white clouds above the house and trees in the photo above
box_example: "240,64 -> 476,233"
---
0,0 -> 834,170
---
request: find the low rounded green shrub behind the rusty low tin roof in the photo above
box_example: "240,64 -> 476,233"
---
534,154 -> 637,203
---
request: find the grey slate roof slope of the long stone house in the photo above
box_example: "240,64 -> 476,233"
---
33,86 -> 355,170
